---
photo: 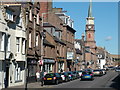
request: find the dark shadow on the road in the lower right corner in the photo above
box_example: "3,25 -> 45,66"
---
110,74 -> 120,90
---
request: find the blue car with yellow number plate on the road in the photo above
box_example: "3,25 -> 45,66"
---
81,71 -> 94,80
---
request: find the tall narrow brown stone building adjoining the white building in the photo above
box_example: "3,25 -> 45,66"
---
25,2 -> 43,82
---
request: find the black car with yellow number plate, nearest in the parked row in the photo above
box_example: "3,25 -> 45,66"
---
44,73 -> 62,84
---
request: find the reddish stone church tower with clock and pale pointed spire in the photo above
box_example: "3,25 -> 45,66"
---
85,0 -> 96,67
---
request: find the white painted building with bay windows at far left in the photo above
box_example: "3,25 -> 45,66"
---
0,4 -> 26,89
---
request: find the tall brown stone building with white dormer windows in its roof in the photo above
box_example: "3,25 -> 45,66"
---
40,2 -> 75,72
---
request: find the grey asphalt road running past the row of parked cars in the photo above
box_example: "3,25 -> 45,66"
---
44,71 -> 120,90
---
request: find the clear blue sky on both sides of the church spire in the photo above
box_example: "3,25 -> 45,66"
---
53,2 -> 118,54
